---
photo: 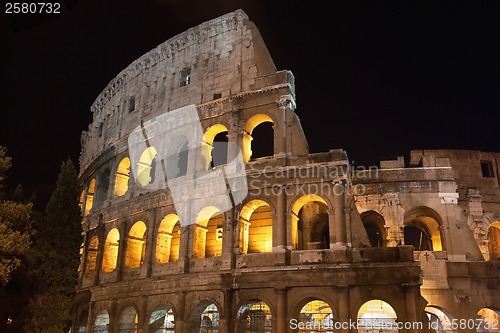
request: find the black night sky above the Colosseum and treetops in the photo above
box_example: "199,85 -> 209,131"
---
0,0 -> 500,208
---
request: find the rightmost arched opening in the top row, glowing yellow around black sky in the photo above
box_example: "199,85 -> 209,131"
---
242,114 -> 274,163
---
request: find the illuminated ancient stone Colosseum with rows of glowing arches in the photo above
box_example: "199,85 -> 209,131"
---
72,10 -> 500,333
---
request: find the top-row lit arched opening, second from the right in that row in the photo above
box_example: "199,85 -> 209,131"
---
201,124 -> 228,170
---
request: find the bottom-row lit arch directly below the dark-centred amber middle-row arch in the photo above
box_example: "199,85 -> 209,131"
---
297,299 -> 334,333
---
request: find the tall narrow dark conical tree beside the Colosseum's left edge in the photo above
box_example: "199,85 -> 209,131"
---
25,159 -> 82,333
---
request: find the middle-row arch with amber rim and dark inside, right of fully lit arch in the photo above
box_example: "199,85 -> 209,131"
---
291,194 -> 330,250
